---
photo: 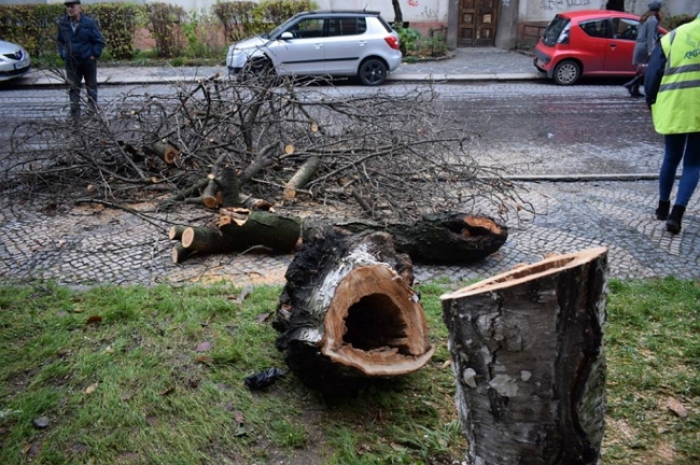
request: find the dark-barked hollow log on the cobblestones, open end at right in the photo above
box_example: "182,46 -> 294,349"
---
303,212 -> 508,264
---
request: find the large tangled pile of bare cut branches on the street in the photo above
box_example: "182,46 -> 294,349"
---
0,73 -> 523,225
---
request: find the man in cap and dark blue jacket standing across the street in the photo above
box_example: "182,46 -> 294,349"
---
56,0 -> 105,118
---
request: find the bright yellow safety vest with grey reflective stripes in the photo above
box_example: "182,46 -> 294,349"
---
652,19 -> 700,134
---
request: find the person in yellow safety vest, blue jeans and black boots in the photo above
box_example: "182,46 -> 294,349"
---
644,15 -> 700,234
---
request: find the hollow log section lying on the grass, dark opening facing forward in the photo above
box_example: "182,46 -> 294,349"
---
273,227 -> 434,390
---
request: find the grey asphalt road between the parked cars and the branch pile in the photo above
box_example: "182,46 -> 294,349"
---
0,82 -> 662,175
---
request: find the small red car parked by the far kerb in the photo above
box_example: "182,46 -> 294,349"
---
532,10 -> 666,86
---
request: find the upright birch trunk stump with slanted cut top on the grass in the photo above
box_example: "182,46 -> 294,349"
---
441,248 -> 607,465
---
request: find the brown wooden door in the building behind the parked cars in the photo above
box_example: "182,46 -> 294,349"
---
457,0 -> 498,47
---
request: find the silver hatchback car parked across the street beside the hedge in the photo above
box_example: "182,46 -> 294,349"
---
226,11 -> 402,86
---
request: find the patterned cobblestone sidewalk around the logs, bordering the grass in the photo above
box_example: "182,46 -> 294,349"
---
0,181 -> 700,286
